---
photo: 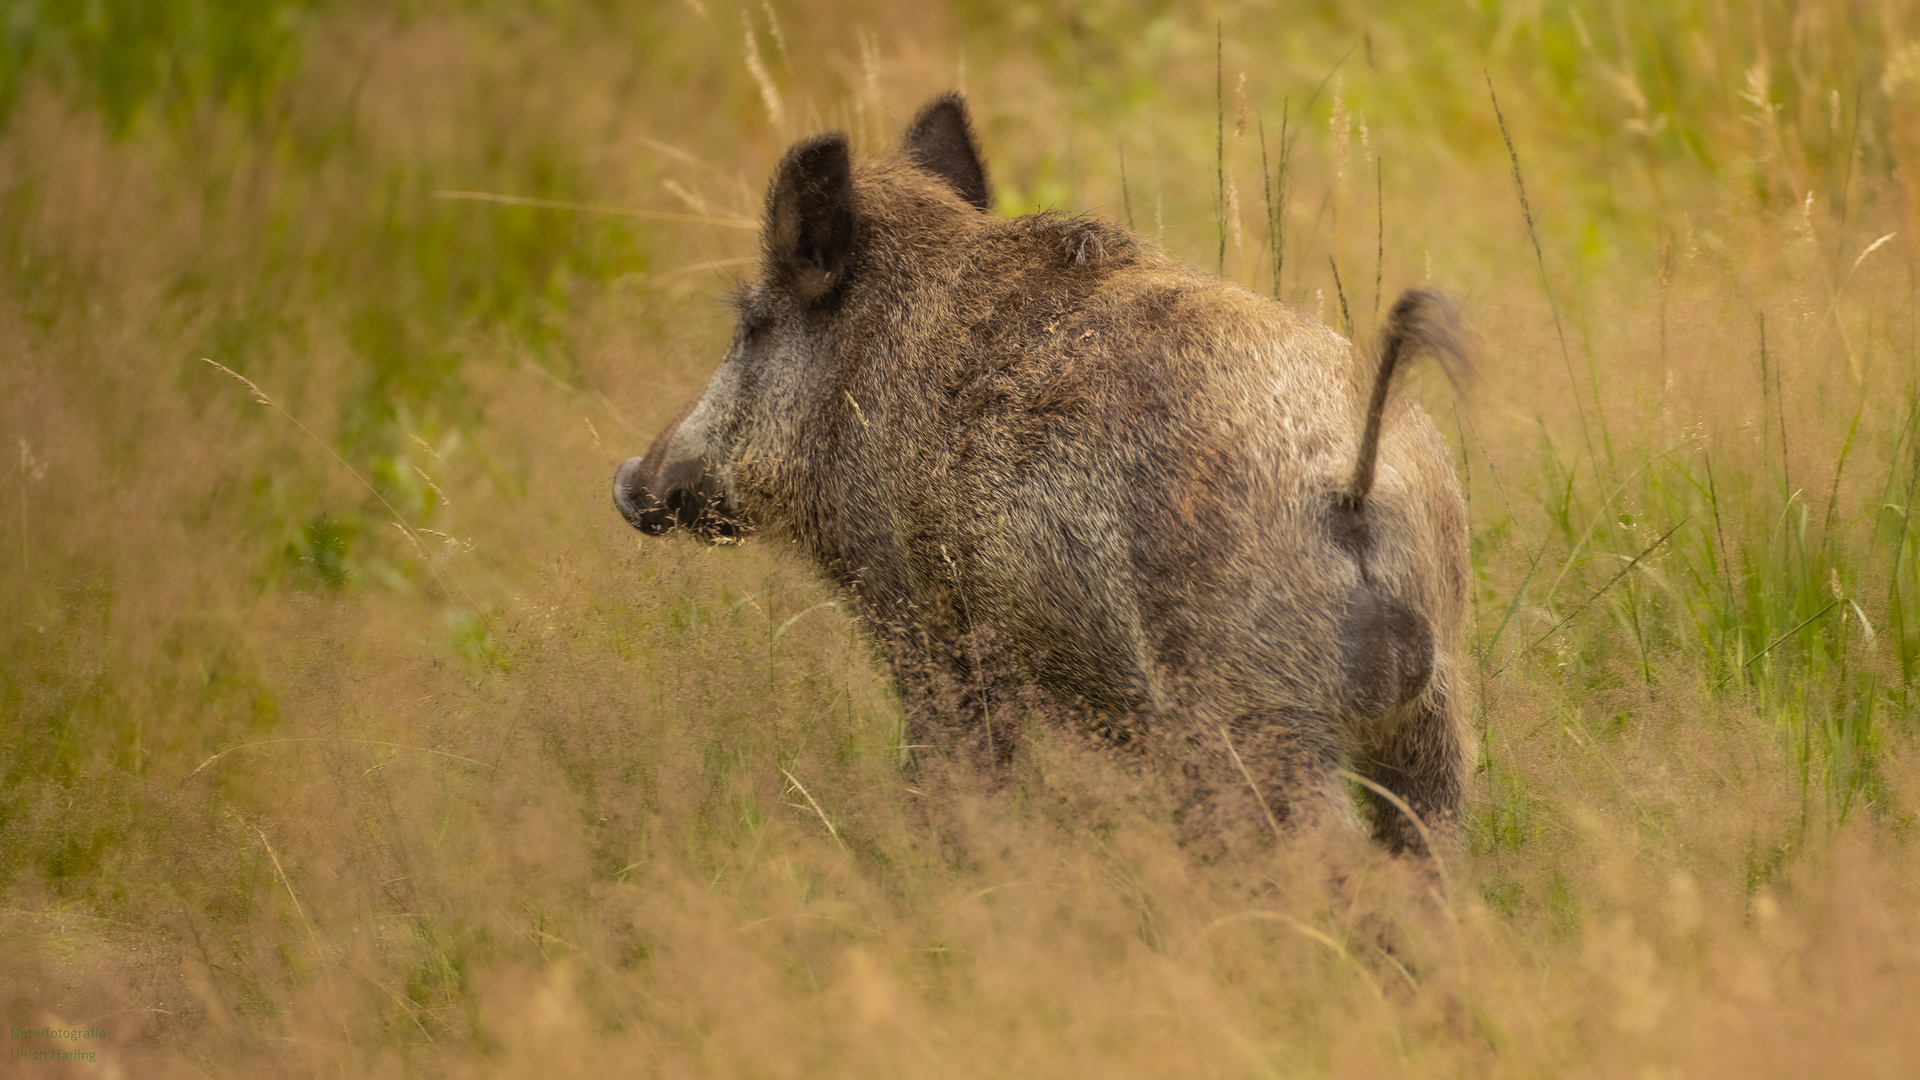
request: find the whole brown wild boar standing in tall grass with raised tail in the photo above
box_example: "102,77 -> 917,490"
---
614,96 -> 1467,855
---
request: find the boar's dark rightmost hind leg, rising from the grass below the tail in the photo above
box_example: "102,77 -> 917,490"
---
1354,682 -> 1465,859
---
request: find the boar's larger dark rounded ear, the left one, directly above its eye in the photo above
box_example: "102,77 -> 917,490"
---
762,131 -> 854,306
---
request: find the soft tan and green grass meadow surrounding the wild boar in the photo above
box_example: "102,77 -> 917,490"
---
0,0 -> 1920,1076
